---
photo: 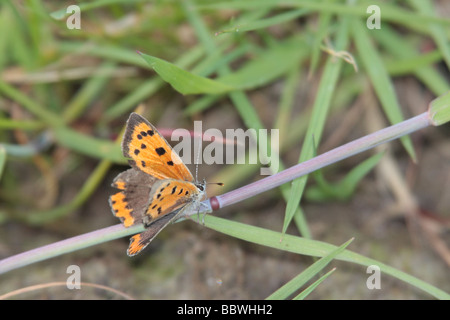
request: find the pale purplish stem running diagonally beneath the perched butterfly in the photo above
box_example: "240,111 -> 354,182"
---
0,112 -> 432,274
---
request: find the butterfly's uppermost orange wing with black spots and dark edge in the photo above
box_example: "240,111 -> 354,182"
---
122,113 -> 194,181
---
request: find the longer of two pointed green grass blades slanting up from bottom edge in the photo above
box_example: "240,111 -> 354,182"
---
267,238 -> 353,300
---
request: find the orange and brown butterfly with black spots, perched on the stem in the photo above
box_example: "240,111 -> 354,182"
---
109,113 -> 206,256
